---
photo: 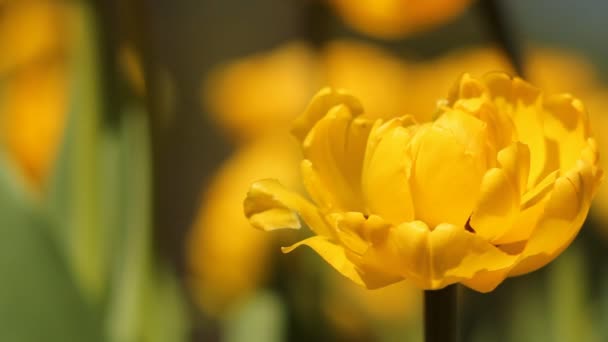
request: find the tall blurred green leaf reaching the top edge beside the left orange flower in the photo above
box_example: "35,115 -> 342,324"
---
47,1 -> 111,302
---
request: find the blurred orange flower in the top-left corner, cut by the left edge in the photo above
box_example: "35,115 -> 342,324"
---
0,0 -> 69,188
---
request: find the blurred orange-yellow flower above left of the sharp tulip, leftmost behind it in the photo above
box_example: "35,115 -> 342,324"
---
204,43 -> 320,141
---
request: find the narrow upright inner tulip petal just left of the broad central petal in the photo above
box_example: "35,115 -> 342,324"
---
362,117 -> 414,224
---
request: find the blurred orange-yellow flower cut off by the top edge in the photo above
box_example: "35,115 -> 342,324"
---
329,0 -> 471,38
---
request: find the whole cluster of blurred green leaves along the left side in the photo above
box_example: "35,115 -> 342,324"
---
0,2 -> 188,342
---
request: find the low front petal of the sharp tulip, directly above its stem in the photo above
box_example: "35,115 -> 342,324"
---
368,221 -> 518,291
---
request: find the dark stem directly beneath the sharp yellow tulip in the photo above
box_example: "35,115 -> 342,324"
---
424,285 -> 460,342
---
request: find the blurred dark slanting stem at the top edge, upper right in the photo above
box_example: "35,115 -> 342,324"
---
478,0 -> 525,77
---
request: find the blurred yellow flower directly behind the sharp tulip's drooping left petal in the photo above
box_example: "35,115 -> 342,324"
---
188,136 -> 298,315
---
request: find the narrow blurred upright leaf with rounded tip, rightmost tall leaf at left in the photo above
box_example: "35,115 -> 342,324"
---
108,107 -> 151,342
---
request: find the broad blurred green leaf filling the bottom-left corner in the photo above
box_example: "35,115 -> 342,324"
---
0,156 -> 101,342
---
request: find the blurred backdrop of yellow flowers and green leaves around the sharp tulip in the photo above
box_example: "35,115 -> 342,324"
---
0,0 -> 608,342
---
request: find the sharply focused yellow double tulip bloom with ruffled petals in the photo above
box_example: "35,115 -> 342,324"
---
244,73 -> 602,292
